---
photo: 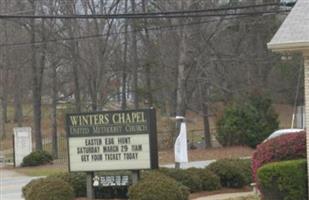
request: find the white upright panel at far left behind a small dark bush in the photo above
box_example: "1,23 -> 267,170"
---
14,127 -> 32,167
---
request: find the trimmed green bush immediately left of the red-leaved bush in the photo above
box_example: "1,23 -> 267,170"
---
207,159 -> 252,188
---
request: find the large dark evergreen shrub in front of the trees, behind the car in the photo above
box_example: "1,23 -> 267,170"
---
217,95 -> 279,148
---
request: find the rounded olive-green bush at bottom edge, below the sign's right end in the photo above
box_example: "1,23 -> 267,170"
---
129,172 -> 189,200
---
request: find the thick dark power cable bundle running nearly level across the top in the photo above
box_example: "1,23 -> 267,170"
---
0,4 -> 287,19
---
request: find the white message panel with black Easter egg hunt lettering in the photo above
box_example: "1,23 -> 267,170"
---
69,134 -> 150,171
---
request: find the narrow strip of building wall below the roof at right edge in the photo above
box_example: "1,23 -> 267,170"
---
304,54 -> 309,195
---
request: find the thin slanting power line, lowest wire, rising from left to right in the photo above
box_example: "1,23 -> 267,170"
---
0,12 -> 286,48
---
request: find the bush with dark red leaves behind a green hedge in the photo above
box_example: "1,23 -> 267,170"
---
252,132 -> 306,181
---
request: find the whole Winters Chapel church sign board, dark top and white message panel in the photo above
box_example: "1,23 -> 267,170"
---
66,109 -> 158,172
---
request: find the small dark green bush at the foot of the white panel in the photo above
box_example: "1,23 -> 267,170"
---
21,151 -> 53,167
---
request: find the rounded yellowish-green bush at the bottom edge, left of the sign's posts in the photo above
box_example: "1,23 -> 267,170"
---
23,178 -> 74,200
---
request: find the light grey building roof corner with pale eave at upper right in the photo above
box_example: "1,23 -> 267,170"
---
267,0 -> 309,51
